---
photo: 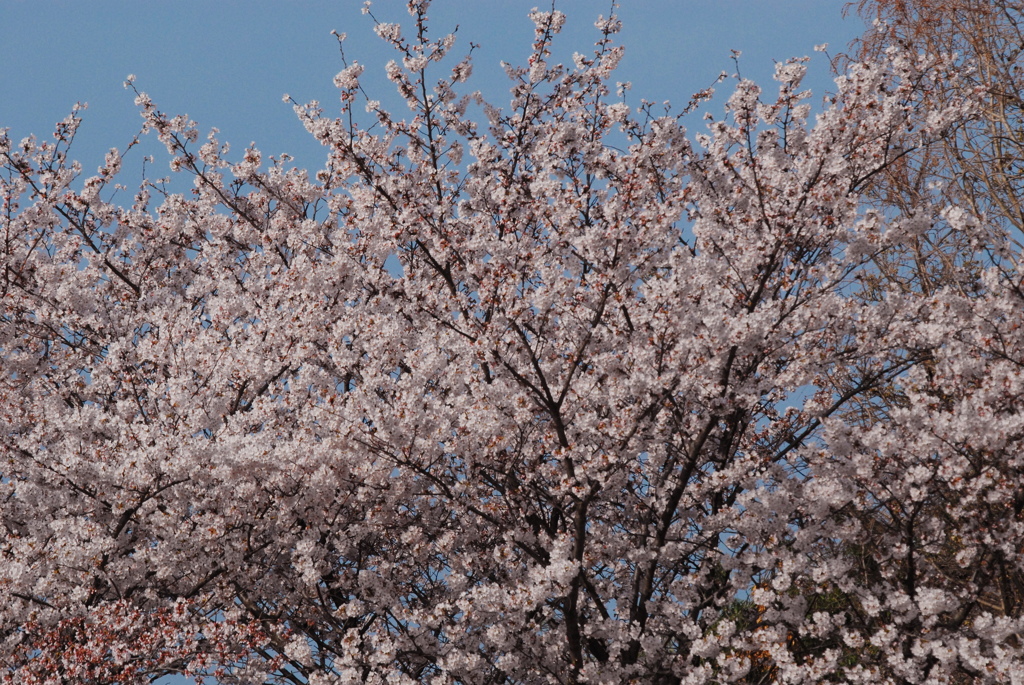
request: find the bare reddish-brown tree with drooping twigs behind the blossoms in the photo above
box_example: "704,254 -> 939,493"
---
851,0 -> 1024,298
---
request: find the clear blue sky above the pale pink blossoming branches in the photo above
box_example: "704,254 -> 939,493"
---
0,0 -> 863,685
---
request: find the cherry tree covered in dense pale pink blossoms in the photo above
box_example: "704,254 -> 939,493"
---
0,0 -> 1024,685
